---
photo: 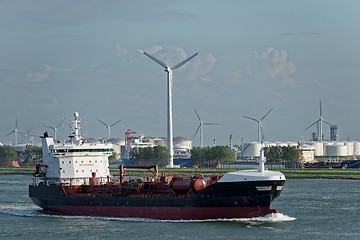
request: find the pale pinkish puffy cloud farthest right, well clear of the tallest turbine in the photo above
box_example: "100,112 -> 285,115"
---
252,47 -> 296,87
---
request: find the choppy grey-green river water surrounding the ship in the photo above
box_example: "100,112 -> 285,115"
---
0,175 -> 360,240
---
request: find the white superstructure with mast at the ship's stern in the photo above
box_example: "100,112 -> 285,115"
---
42,112 -> 113,185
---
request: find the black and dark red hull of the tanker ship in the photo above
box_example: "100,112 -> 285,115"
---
29,181 -> 285,220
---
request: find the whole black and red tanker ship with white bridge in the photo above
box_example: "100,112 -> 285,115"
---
29,112 -> 286,220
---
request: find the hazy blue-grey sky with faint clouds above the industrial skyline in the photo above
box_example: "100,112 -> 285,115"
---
0,0 -> 360,146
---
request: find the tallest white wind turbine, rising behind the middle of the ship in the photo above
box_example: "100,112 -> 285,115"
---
139,49 -> 198,167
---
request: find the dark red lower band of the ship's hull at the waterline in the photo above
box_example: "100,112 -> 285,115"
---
44,206 -> 277,220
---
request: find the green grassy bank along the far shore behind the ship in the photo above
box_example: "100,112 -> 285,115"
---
0,167 -> 360,180
